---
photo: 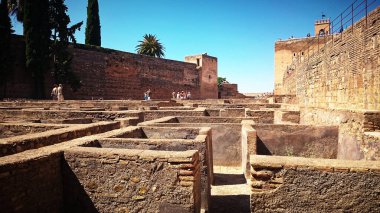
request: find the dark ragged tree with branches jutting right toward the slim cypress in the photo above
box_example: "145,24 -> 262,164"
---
49,0 -> 83,91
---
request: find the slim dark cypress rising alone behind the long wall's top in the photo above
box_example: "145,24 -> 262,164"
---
85,0 -> 101,46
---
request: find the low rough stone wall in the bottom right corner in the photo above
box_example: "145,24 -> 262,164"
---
250,155 -> 380,212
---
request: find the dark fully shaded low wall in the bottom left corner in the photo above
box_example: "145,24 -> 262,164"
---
0,153 -> 63,212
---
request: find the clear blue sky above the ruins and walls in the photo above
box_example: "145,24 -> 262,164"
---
13,0 -> 379,92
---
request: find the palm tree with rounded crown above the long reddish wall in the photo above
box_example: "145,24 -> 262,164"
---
136,34 -> 165,58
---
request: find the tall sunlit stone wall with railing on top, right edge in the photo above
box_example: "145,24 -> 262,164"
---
283,7 -> 380,110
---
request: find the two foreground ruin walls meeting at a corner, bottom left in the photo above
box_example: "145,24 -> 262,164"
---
0,145 -> 201,213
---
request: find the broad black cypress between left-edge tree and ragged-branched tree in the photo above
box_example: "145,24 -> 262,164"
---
23,0 -> 51,99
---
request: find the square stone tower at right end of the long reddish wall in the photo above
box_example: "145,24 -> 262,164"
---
185,53 -> 218,99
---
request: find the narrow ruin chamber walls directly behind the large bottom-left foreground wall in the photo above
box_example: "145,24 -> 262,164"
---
83,127 -> 213,210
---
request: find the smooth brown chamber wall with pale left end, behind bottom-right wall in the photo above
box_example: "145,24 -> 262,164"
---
241,123 -> 339,179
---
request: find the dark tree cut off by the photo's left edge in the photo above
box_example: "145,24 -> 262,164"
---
0,0 -> 13,99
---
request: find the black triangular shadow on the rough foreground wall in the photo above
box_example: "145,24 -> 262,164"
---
61,159 -> 98,212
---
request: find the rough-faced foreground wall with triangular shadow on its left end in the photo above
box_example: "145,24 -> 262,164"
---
63,147 -> 201,213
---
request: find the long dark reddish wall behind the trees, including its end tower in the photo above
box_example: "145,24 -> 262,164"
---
6,36 -> 218,100
